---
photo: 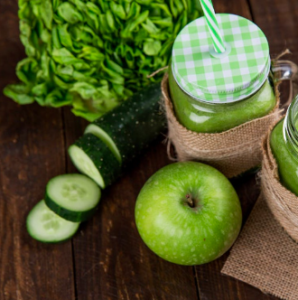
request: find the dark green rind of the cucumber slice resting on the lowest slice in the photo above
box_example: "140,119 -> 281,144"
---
44,190 -> 97,222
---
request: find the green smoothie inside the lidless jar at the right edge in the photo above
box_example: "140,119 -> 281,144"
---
270,119 -> 298,196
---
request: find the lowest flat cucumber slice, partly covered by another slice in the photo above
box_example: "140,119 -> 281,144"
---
26,200 -> 80,243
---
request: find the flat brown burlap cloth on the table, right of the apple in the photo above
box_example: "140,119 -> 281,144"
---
221,197 -> 298,300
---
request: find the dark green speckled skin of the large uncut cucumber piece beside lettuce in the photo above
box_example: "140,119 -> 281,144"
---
85,83 -> 166,167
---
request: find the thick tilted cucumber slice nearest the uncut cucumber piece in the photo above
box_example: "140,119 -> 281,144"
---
68,133 -> 121,188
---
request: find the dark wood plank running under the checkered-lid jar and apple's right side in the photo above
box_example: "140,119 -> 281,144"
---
195,0 -> 276,300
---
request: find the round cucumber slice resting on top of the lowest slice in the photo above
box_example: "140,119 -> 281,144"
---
45,174 -> 100,222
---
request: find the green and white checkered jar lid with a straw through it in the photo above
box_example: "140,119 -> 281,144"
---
172,14 -> 270,103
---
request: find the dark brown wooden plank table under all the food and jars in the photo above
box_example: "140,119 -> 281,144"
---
0,0 -> 298,300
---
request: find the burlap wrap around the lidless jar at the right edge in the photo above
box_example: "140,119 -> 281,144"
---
261,126 -> 298,242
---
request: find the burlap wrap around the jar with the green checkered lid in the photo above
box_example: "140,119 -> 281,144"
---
161,73 -> 280,178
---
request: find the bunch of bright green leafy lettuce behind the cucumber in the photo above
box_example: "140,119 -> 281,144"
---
4,0 -> 201,121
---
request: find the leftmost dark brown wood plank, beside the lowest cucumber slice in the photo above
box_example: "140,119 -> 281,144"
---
0,0 -> 74,300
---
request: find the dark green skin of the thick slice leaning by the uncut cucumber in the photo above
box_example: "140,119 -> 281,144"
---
73,133 -> 121,188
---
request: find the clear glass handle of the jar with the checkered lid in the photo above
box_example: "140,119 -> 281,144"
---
271,60 -> 298,108
